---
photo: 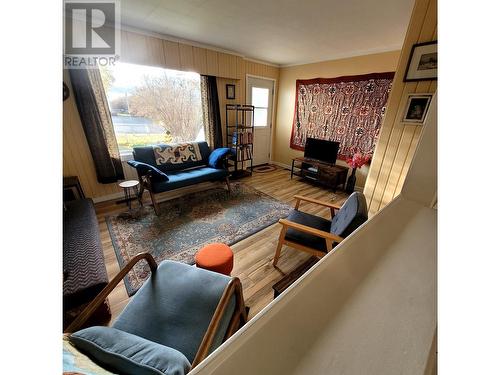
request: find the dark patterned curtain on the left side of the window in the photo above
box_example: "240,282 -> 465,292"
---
69,69 -> 124,184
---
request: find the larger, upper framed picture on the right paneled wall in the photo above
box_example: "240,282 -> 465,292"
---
403,40 -> 438,82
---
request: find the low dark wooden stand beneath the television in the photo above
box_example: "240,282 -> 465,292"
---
290,157 -> 349,192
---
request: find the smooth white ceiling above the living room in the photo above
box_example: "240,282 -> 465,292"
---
121,0 -> 414,65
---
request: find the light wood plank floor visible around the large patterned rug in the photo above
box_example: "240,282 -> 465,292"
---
96,167 -> 347,319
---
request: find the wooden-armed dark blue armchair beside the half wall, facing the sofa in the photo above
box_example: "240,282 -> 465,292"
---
273,192 -> 368,266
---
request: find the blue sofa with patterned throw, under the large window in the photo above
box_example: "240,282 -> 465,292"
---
128,142 -> 231,215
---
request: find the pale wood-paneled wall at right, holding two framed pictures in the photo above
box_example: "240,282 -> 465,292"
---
364,0 -> 437,214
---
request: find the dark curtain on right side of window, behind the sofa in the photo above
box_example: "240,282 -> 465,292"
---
201,75 -> 223,149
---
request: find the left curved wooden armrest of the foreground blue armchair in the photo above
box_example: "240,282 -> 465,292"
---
64,253 -> 158,333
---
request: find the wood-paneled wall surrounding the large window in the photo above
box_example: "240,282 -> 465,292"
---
63,31 -> 279,199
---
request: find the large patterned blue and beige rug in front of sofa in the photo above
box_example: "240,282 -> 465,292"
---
106,183 -> 292,296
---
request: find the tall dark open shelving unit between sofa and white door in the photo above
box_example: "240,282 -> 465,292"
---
226,104 -> 254,178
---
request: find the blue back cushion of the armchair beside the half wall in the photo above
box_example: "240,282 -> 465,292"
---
330,191 -> 368,238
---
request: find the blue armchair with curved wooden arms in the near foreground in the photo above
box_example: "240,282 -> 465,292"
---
66,253 -> 247,375
